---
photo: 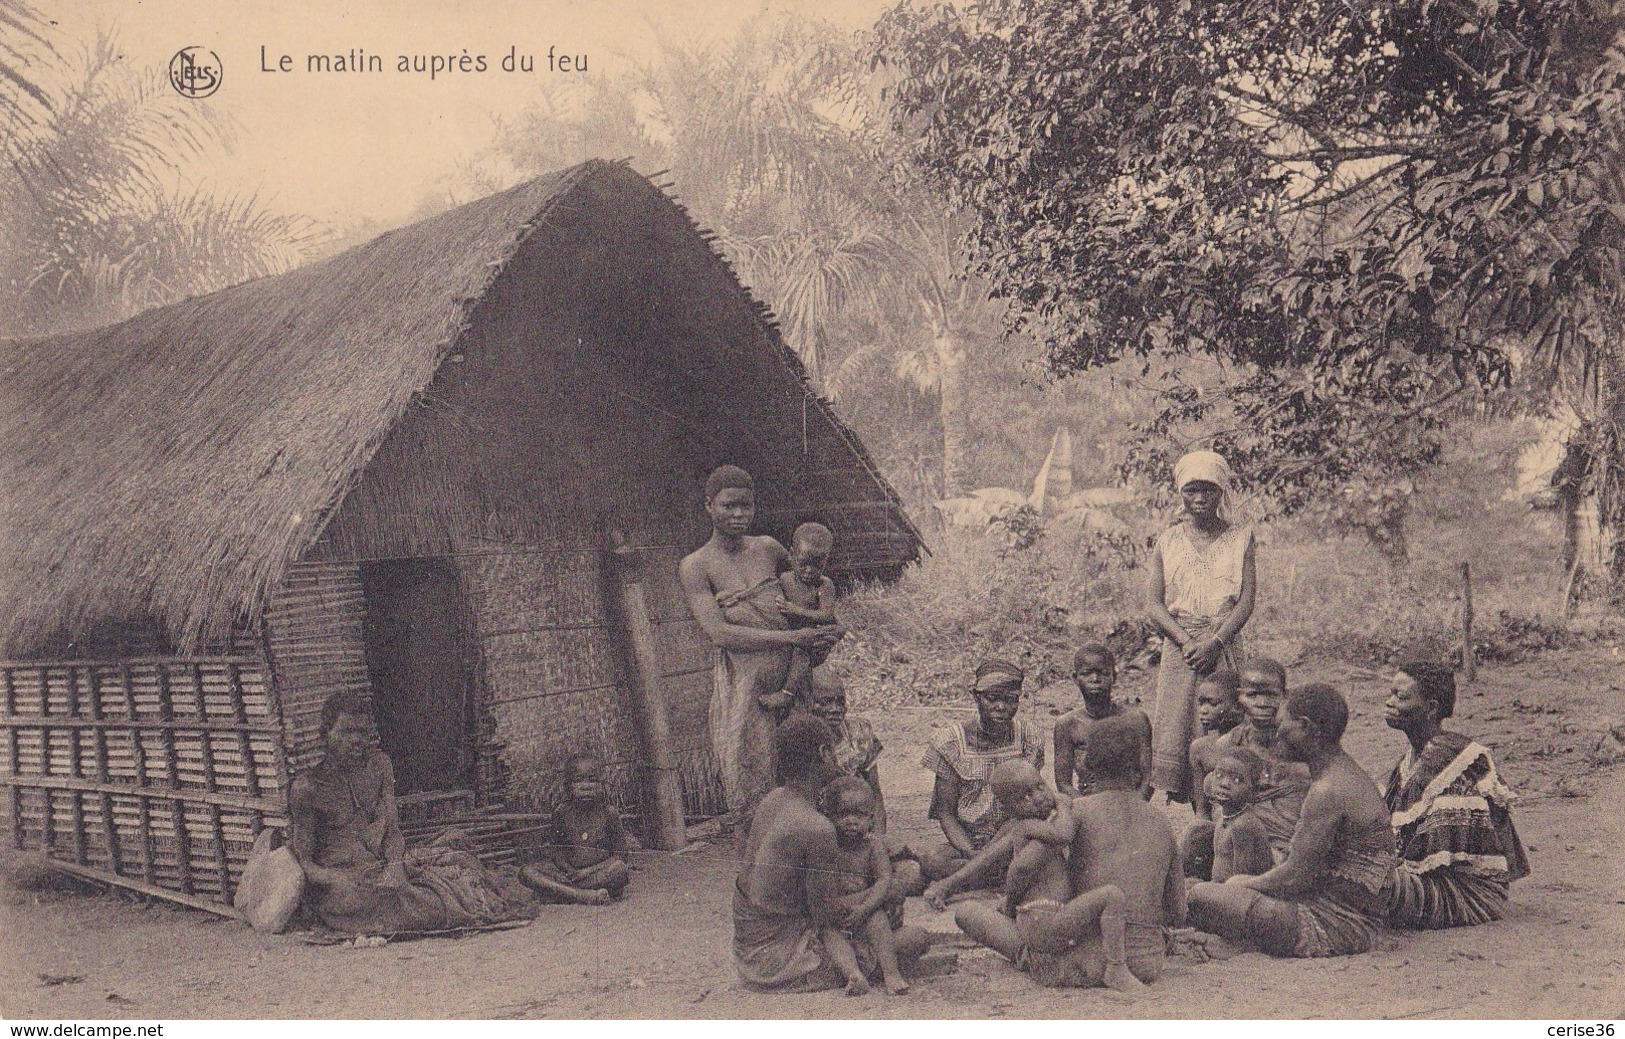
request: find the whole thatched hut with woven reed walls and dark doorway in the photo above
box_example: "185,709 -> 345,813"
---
0,161 -> 921,888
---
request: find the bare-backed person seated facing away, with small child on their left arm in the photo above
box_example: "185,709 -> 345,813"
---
954,719 -> 1185,992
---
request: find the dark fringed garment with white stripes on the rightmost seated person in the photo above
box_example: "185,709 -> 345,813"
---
1385,732 -> 1529,930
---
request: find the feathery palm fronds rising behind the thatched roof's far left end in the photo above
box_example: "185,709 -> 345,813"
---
0,36 -> 317,333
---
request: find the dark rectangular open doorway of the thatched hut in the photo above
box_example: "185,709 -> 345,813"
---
361,559 -> 473,793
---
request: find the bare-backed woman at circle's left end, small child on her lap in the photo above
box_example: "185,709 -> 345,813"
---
733,714 -> 926,992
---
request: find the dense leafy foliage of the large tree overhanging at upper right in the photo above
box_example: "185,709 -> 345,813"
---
878,0 -> 1625,507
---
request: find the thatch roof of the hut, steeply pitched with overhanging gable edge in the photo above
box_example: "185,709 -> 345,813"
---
0,161 -> 918,654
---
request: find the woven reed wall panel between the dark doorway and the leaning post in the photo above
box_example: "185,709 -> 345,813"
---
458,548 -> 642,810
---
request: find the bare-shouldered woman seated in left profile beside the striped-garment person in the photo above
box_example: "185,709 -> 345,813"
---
1190,685 -> 1394,956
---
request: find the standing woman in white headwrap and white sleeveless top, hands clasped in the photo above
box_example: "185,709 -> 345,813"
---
1147,450 -> 1255,802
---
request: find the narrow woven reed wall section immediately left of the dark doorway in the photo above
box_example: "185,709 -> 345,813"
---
265,563 -> 372,772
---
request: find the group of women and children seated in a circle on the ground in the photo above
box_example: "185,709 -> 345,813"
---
735,644 -> 1529,992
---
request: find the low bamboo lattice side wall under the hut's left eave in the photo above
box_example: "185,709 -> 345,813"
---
0,657 -> 288,902
